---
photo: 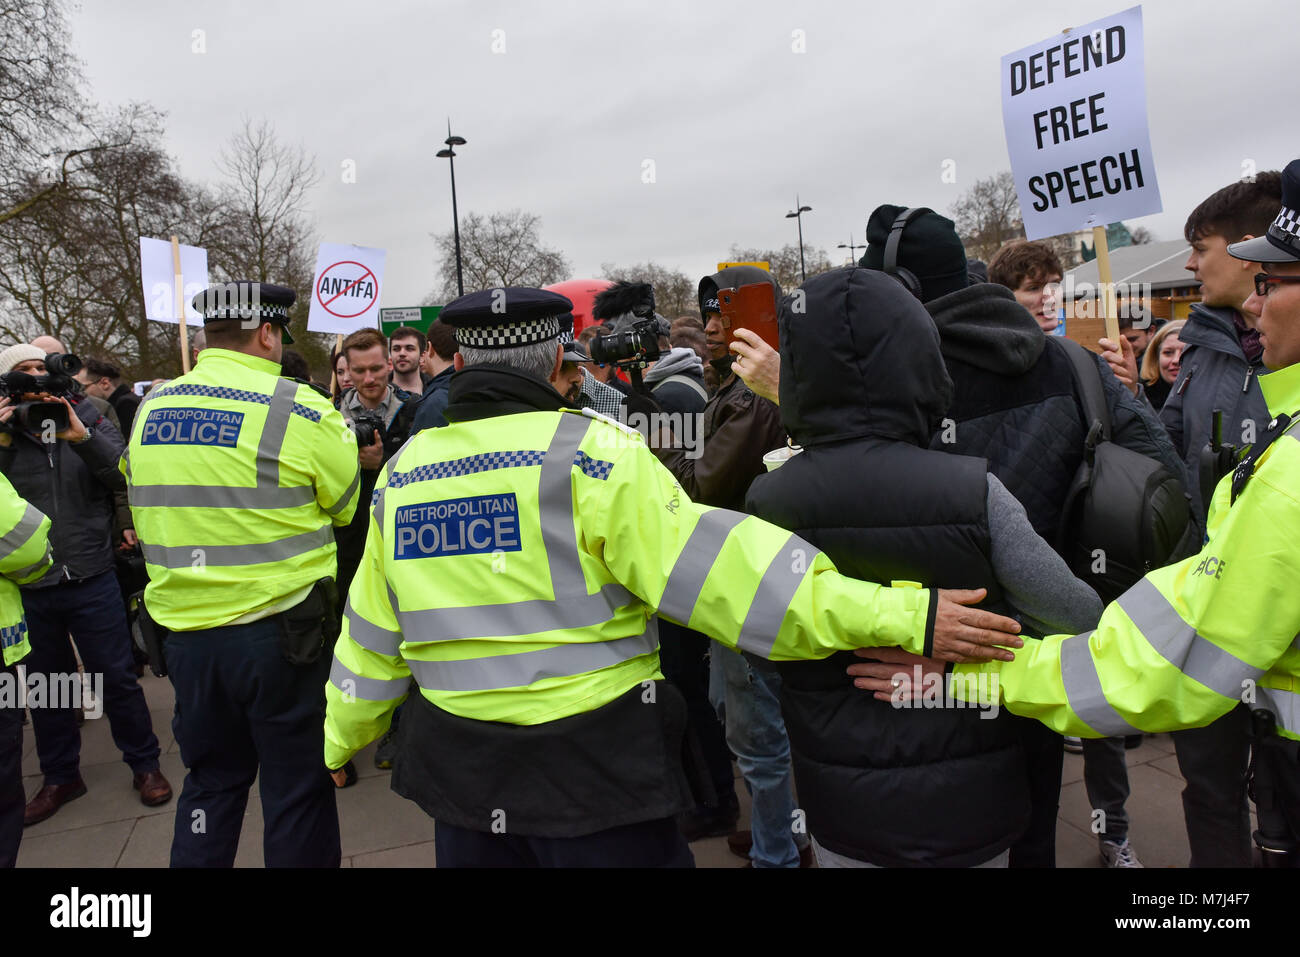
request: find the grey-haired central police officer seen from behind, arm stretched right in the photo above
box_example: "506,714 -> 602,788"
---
325,287 -> 1019,866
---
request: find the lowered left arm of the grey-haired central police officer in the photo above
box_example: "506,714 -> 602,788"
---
325,462 -> 411,770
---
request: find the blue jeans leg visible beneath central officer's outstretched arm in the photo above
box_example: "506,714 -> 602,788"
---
709,641 -> 807,867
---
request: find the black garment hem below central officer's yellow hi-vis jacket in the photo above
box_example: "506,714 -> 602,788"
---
393,681 -> 693,837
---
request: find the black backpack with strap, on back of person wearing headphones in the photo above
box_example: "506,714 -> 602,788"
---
1048,337 -> 1197,602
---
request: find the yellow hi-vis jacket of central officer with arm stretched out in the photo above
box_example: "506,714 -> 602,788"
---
325,411 -> 933,768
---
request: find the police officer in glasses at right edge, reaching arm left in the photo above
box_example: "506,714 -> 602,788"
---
925,160 -> 1300,866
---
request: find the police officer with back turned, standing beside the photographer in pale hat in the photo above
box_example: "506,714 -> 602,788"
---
121,282 -> 359,867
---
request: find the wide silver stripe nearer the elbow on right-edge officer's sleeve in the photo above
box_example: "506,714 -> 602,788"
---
1117,579 -> 1268,698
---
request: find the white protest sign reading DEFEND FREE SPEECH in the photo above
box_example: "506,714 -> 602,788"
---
1002,7 -> 1161,239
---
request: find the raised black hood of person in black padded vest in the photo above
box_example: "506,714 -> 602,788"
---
779,267 -> 951,446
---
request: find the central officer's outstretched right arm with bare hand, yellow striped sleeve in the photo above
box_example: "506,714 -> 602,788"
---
584,434 -> 1022,661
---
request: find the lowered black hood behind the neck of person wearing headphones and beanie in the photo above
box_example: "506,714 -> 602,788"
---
926,282 -> 1047,376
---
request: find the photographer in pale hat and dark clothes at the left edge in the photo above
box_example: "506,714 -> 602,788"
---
0,345 -> 172,824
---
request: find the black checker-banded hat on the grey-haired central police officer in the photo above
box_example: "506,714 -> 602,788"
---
438,286 -> 573,348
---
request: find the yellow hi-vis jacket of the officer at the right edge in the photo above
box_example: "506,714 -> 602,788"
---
952,365 -> 1300,739
